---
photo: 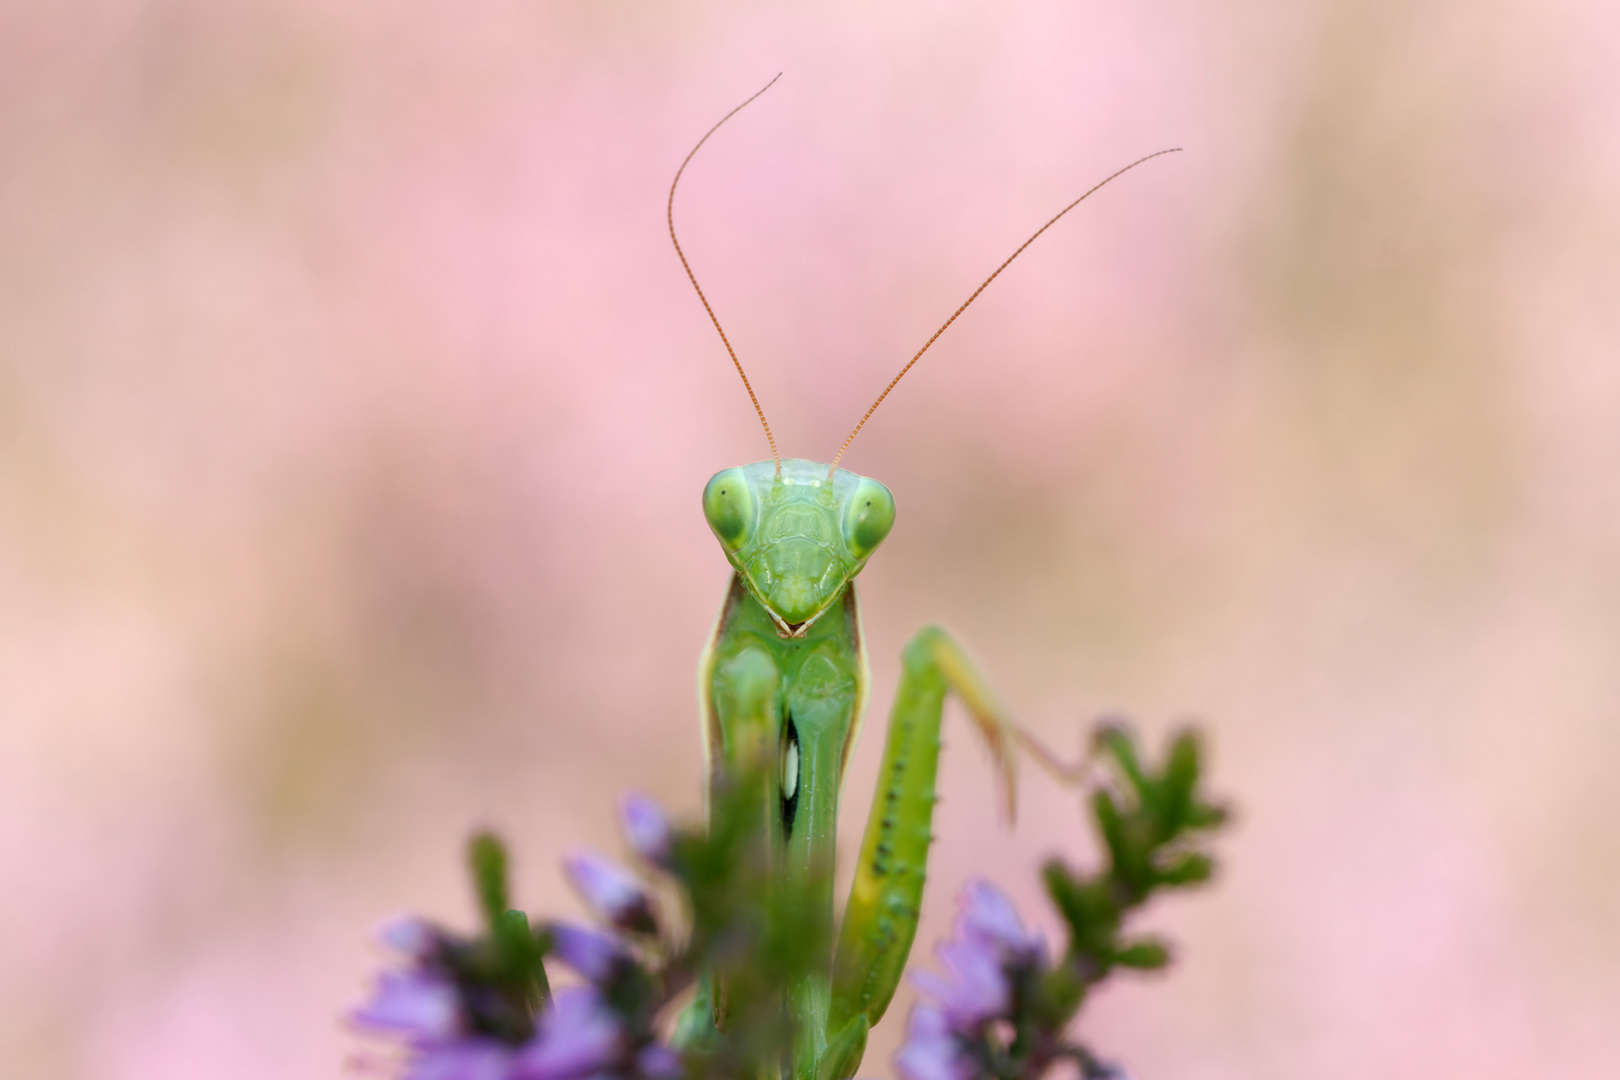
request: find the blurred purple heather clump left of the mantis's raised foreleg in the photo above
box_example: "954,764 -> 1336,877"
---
352,774 -> 831,1080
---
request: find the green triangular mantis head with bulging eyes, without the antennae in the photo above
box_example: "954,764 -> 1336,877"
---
703,458 -> 894,638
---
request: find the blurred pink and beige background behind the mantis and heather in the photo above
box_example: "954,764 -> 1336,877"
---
0,0 -> 1620,1080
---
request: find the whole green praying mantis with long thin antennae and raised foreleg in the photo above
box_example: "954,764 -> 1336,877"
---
667,79 -> 1173,1080
